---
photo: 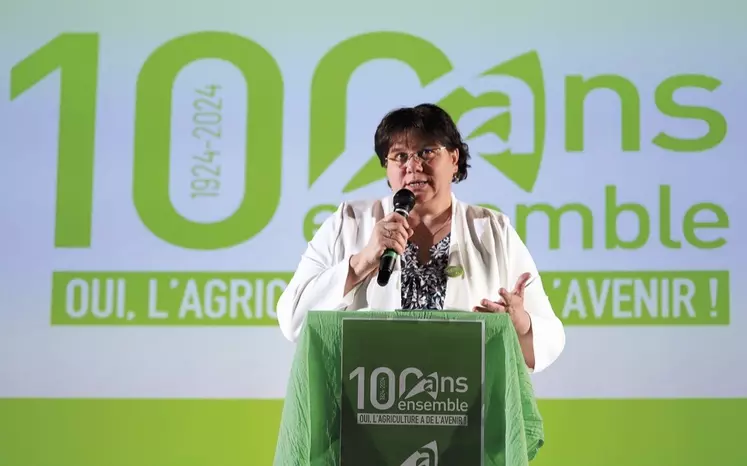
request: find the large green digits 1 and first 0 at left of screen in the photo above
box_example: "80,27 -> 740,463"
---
10,32 -> 283,249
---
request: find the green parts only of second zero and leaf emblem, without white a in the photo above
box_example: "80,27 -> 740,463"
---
309,32 -> 546,193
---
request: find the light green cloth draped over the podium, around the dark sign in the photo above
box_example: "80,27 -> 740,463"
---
274,311 -> 544,466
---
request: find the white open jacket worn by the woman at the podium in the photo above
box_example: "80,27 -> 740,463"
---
277,194 -> 565,372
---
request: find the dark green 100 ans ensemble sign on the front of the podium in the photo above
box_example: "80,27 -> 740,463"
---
340,317 -> 485,466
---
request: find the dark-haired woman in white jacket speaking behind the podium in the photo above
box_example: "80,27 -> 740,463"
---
277,104 -> 565,372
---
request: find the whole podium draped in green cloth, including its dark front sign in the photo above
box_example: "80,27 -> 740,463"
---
274,311 -> 544,466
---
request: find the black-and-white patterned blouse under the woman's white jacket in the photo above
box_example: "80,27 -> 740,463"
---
400,233 -> 451,311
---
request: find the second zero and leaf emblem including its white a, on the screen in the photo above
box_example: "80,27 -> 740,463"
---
308,32 -> 546,193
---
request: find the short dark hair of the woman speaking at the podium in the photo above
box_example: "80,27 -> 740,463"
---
374,104 -> 470,182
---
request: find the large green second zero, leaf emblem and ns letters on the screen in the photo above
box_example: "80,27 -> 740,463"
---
308,32 -> 727,193
